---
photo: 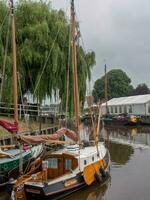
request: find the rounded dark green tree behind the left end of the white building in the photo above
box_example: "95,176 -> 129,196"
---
93,69 -> 133,102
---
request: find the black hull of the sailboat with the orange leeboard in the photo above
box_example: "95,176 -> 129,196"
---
24,152 -> 110,200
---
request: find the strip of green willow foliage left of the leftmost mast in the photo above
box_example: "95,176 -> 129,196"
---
0,1 -> 12,102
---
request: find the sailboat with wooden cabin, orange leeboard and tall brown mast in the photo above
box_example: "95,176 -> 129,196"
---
12,0 -> 110,200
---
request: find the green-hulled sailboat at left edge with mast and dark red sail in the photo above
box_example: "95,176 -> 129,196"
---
0,0 -> 43,188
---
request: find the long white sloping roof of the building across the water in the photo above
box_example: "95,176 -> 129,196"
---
102,94 -> 150,106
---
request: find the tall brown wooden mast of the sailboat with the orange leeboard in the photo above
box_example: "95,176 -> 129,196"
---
71,0 -> 80,131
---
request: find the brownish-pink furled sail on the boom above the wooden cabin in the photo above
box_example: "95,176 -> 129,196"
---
19,128 -> 78,144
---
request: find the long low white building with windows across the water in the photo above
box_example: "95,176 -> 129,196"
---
102,94 -> 150,115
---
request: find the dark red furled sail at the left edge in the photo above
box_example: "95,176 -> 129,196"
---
0,120 -> 18,133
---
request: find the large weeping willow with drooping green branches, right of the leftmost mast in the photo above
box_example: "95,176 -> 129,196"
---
0,0 -> 95,115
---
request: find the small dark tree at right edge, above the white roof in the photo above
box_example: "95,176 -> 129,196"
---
130,83 -> 150,95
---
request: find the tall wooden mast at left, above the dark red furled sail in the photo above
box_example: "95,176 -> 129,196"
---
10,0 -> 18,123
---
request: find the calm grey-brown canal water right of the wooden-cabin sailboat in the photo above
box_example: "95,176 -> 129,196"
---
0,126 -> 150,200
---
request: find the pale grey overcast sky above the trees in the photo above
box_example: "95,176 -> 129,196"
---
52,0 -> 150,87
